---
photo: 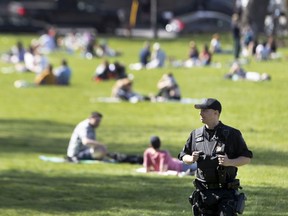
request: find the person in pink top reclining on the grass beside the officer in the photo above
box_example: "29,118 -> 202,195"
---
143,136 -> 197,172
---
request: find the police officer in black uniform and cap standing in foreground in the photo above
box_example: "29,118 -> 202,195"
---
178,98 -> 253,216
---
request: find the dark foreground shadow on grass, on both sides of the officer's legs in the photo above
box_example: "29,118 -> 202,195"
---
0,170 -> 288,215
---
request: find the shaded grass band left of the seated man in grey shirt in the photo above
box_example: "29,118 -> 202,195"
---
0,119 -> 74,154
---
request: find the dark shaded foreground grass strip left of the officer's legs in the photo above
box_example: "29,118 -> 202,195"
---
0,170 -> 186,215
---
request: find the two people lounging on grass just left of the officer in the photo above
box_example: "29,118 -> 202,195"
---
67,112 -> 197,174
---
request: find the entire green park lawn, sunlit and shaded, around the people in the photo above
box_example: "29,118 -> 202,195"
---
0,32 -> 288,216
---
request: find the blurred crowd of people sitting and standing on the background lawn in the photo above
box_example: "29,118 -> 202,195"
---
1,14 -> 282,92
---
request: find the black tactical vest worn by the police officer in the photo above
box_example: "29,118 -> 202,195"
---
192,125 -> 237,184
